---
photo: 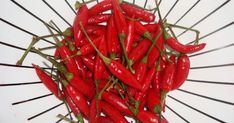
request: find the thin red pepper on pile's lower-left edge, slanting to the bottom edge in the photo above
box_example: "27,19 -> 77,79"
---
64,87 -> 84,123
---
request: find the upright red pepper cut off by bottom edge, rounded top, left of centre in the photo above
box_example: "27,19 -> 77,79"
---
89,98 -> 101,123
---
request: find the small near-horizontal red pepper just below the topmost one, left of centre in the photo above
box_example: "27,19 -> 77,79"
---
88,14 -> 111,24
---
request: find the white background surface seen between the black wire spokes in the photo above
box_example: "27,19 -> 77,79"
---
0,0 -> 234,123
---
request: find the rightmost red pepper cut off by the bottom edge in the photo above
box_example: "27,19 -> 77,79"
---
136,110 -> 168,123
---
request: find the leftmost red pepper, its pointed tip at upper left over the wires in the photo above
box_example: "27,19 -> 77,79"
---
32,64 -> 64,100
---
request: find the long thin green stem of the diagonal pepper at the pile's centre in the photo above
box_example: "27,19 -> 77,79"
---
80,22 -> 111,65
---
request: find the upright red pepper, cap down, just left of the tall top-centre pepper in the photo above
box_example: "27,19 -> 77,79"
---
106,16 -> 121,59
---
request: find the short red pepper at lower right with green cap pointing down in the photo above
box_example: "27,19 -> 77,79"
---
146,88 -> 162,114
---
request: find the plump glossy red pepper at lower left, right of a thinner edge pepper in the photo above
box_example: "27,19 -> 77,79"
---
65,84 -> 90,117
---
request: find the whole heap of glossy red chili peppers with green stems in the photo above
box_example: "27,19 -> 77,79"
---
18,0 -> 206,123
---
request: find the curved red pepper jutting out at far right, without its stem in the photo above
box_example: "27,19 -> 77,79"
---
166,37 -> 206,54
